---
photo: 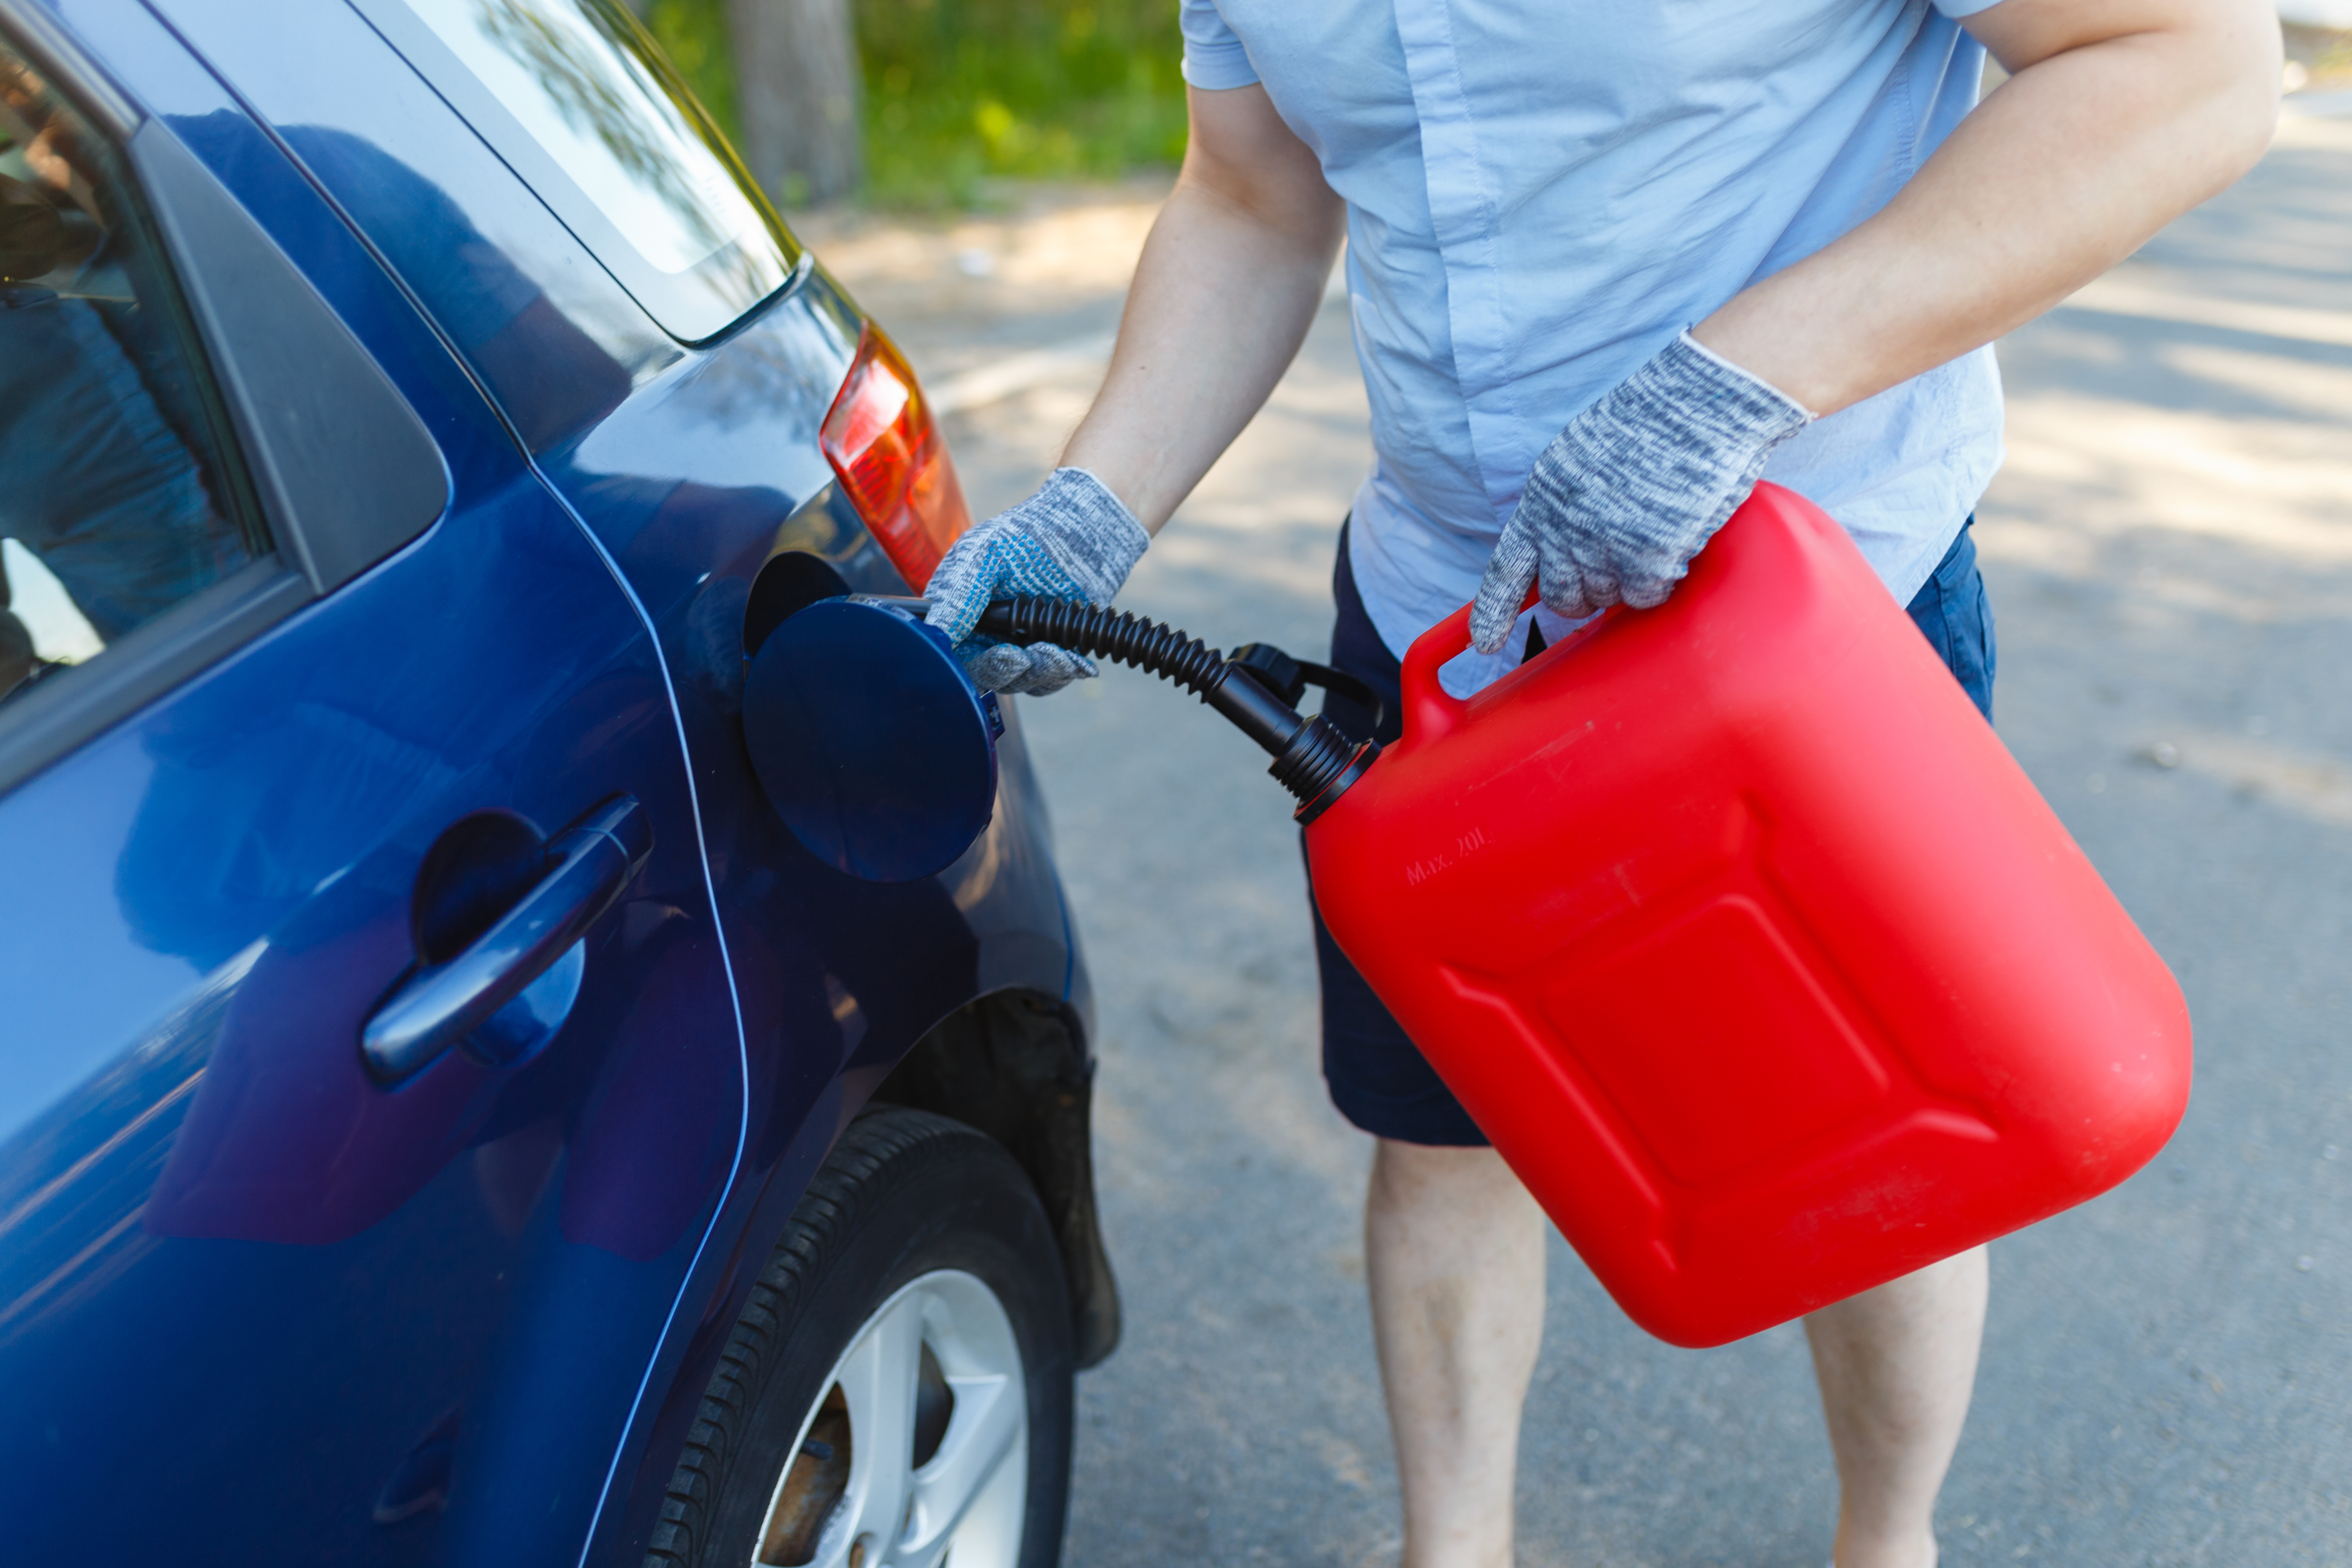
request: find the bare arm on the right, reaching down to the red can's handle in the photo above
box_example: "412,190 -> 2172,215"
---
1691,0 -> 2279,414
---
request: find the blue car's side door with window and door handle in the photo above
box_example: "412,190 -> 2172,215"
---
0,0 -> 743,1563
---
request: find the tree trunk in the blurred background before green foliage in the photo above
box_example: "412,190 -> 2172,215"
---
729,0 -> 863,207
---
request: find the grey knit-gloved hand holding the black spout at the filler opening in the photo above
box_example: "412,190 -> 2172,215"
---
924,468 -> 1152,696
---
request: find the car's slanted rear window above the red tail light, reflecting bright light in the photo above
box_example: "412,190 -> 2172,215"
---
353,0 -> 799,343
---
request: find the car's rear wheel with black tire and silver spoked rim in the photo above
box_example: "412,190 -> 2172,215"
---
644,1107 -> 1072,1568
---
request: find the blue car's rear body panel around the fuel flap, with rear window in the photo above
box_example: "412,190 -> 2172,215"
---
133,0 -> 1108,1561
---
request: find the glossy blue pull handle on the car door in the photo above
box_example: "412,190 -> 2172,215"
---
360,795 -> 654,1084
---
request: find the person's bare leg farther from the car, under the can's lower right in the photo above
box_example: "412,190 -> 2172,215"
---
1804,1248 -> 1988,1568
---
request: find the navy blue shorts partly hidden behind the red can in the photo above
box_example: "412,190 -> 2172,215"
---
1308,517 -> 1994,1149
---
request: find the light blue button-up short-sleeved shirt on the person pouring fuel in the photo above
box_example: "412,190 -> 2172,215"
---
1183,0 -> 2002,686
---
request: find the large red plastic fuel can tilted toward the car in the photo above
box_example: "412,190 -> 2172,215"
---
1305,484 -> 2190,1344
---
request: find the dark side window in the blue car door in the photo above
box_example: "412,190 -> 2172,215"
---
0,42 -> 268,705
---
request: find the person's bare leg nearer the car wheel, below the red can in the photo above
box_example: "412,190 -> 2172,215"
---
1364,1138 -> 1543,1568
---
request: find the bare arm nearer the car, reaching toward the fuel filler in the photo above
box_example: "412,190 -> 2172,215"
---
1061,87 -> 1345,534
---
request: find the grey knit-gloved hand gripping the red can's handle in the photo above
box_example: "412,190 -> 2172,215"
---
1470,331 -> 1813,653
